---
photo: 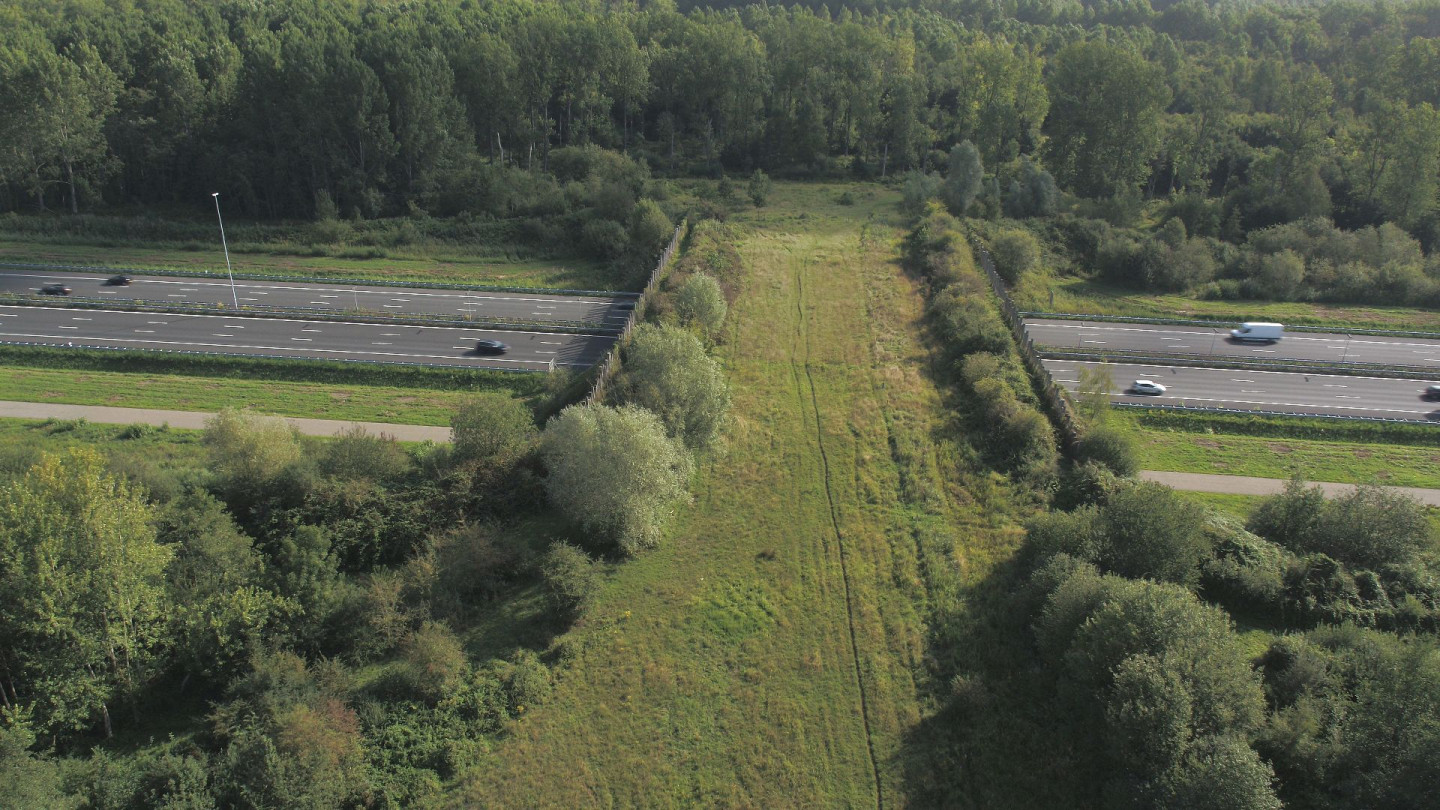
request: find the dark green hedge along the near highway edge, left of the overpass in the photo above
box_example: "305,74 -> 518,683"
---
0,346 -> 546,398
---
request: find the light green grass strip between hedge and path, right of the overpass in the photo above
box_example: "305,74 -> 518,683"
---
1136,430 -> 1440,489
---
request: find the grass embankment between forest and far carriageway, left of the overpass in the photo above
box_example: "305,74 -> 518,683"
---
0,239 -> 616,290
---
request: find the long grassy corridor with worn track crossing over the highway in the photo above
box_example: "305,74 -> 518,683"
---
459,184 -> 1012,807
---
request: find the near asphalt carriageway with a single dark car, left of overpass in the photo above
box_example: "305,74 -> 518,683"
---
0,306 -> 615,369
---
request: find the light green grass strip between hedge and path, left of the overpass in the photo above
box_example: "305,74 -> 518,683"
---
0,358 -> 489,425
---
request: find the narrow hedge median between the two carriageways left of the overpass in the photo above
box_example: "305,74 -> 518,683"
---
0,293 -> 621,334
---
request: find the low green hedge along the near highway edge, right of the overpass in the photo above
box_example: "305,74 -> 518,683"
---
1130,409 -> 1440,447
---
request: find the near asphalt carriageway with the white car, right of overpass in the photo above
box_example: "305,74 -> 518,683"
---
1044,360 -> 1440,422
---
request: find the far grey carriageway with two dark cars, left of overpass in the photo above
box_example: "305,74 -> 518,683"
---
0,270 -> 634,326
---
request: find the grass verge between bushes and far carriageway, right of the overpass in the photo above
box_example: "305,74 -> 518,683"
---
1012,271 -> 1440,331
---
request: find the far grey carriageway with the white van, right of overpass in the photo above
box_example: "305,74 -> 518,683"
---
1025,320 -> 1440,366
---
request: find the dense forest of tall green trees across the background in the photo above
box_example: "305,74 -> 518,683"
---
0,0 -> 1440,241
